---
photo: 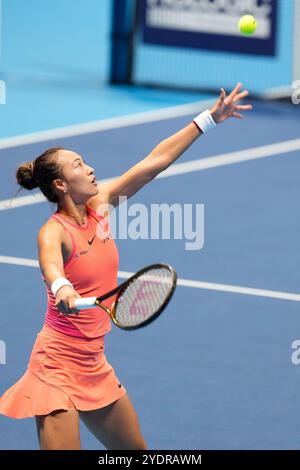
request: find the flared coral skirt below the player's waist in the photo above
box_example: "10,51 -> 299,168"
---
0,326 -> 126,418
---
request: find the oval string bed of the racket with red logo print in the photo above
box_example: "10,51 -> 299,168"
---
115,268 -> 174,326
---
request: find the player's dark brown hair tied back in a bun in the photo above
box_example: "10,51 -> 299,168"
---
16,147 -> 64,202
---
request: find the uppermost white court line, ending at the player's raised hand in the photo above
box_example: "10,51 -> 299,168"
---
0,99 -> 216,149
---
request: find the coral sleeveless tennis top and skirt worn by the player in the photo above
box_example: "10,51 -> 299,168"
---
0,206 -> 126,418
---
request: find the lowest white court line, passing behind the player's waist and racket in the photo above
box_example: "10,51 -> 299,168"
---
0,256 -> 300,302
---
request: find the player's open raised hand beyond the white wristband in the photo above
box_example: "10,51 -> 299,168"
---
210,83 -> 252,124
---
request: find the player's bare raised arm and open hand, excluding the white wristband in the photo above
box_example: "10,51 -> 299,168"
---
92,83 -> 252,206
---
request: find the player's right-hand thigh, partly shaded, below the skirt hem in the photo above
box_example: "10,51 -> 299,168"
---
79,394 -> 147,450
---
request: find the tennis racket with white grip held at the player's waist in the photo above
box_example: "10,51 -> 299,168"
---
75,263 -> 177,330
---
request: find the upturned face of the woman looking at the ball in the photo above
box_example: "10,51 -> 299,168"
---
58,150 -> 98,203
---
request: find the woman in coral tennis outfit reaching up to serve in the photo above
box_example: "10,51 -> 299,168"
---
0,83 -> 252,450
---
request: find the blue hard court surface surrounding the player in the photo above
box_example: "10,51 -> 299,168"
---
0,0 -> 300,449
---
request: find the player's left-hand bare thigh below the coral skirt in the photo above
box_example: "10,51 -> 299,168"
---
35,408 -> 80,450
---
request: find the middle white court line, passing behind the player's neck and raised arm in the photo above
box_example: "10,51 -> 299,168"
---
0,135 -> 300,211
